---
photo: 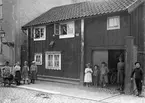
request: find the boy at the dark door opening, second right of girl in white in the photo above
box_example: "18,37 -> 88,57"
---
100,62 -> 109,87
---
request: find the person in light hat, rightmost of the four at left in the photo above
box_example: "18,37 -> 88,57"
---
30,61 -> 37,84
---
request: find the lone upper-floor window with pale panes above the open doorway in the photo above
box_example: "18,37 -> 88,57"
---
107,16 -> 120,30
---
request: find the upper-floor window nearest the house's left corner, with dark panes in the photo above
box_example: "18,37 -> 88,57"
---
34,27 -> 46,41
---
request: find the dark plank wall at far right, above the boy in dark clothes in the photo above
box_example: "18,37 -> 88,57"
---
130,4 -> 145,68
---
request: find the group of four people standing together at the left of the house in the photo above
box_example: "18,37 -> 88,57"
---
1,61 -> 37,85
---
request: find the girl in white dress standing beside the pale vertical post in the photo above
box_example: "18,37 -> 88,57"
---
84,63 -> 93,87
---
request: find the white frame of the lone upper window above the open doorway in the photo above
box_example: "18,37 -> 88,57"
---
107,16 -> 120,30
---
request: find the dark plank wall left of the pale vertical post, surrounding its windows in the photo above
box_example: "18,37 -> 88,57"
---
26,20 -> 80,79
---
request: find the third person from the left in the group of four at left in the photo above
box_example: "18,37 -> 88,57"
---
22,61 -> 29,84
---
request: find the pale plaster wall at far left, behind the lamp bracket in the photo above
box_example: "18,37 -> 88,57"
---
0,0 -> 17,64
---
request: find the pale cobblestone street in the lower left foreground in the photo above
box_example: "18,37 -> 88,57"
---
0,87 -> 101,103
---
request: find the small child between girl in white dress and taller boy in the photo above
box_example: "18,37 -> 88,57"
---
93,65 -> 100,86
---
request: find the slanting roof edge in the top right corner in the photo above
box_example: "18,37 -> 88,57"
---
127,0 -> 145,13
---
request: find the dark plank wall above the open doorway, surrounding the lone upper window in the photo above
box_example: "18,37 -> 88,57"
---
85,12 -> 130,63
